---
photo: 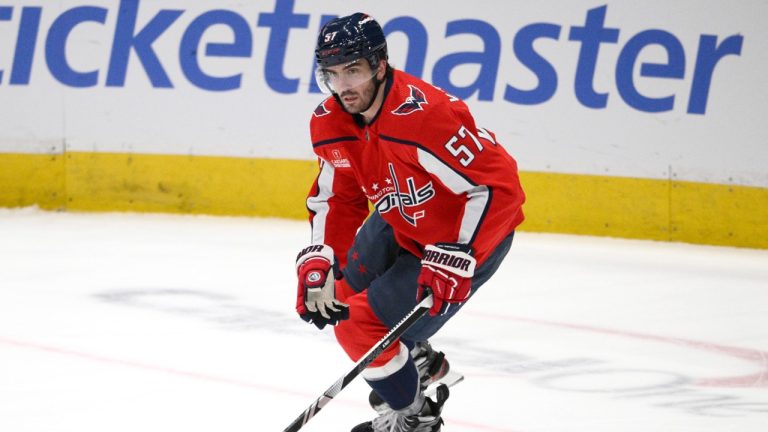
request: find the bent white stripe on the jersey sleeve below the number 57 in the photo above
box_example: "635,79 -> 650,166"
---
416,148 -> 491,244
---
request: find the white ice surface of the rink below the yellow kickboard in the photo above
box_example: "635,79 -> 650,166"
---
0,209 -> 768,432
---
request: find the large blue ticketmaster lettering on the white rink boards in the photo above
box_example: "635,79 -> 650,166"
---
0,0 -> 744,114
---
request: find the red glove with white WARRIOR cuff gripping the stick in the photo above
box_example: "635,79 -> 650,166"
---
418,243 -> 477,316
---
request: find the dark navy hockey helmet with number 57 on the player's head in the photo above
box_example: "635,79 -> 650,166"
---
315,12 -> 387,69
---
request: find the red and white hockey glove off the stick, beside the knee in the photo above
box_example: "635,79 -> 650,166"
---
296,245 -> 349,329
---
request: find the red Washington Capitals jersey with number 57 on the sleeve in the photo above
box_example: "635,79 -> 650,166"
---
307,70 -> 525,266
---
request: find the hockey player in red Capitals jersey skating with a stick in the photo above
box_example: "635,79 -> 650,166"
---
296,13 -> 524,432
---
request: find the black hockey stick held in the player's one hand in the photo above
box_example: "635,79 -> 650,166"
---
283,293 -> 433,432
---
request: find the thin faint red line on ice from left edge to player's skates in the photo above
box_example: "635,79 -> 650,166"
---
0,336 -> 523,432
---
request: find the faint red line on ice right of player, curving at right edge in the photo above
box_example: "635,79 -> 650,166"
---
465,311 -> 768,388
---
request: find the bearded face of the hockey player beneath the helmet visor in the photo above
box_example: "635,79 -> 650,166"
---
323,60 -> 380,114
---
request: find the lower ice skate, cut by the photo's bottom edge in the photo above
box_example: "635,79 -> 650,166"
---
352,384 -> 449,432
